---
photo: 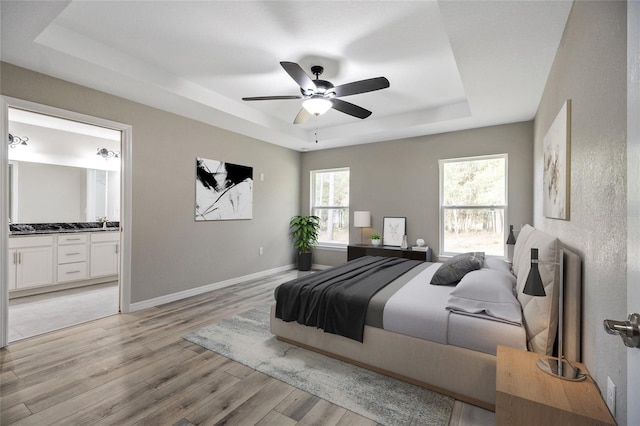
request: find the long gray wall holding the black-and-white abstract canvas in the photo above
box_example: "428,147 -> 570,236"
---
0,63 -> 300,303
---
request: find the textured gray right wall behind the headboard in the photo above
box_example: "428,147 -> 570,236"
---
534,1 -> 637,425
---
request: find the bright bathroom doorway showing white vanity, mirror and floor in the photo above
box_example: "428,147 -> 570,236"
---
0,99 -> 130,346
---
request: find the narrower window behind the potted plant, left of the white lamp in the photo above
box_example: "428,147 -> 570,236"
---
311,168 -> 349,246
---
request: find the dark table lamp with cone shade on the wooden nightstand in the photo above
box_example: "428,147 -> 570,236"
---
522,248 -> 586,382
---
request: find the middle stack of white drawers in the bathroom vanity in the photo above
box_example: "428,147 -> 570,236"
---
56,234 -> 88,283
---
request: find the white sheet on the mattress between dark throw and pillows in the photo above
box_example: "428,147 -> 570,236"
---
383,263 -> 527,355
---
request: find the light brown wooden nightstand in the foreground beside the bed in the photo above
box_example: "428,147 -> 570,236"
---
496,346 -> 616,426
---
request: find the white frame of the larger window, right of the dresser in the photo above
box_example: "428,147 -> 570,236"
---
438,153 -> 509,259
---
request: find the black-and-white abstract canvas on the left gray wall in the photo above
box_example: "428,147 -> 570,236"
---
195,157 -> 253,221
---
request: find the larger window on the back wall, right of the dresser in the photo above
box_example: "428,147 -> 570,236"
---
439,154 -> 508,256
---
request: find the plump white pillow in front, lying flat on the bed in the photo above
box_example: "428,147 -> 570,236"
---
447,269 -> 522,325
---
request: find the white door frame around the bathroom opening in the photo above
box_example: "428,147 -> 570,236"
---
0,96 -> 132,348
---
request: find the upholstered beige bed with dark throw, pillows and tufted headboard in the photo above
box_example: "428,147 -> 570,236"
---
270,225 -> 581,410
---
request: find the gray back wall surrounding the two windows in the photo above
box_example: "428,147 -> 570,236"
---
300,122 -> 533,266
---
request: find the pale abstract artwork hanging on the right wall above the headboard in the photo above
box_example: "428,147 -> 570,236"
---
542,100 -> 571,220
